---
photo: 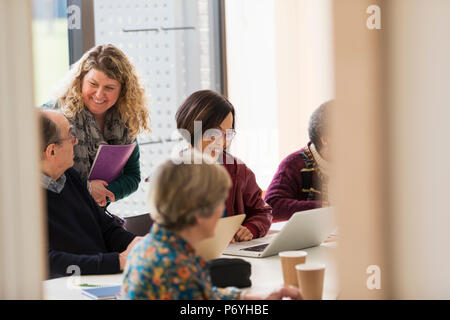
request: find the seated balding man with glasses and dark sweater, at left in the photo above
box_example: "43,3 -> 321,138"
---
40,111 -> 141,278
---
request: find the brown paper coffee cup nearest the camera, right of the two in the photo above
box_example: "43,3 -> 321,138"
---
295,263 -> 325,300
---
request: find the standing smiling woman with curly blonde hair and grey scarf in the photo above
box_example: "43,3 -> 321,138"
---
46,44 -> 150,206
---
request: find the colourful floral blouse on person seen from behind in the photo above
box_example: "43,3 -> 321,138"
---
122,223 -> 240,300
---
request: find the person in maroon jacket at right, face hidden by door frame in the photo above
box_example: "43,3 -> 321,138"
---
264,101 -> 333,221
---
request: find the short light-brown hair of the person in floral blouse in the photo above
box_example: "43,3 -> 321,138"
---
149,153 -> 232,231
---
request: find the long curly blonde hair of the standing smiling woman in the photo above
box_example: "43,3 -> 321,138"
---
55,44 -> 150,138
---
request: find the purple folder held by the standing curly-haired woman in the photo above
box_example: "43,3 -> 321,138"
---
88,142 -> 136,183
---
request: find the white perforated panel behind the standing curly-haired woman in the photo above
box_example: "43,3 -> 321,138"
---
94,0 -> 220,216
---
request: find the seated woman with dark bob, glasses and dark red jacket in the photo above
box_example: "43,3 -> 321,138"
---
175,90 -> 272,242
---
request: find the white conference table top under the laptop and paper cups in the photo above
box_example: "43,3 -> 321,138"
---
43,223 -> 338,300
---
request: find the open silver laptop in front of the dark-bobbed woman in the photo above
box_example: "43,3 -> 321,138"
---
223,207 -> 336,258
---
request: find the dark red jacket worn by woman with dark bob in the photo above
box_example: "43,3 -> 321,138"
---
223,153 -> 272,238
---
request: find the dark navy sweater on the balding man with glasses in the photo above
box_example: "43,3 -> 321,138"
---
46,168 -> 135,278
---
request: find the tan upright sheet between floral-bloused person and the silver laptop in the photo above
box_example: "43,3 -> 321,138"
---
195,214 -> 245,260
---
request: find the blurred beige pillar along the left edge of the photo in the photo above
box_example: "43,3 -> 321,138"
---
0,0 -> 46,299
